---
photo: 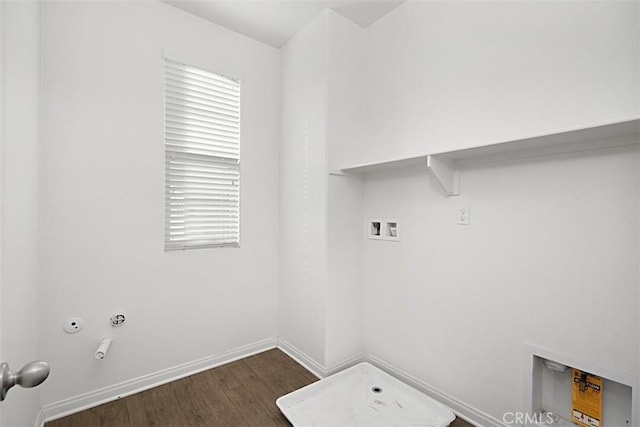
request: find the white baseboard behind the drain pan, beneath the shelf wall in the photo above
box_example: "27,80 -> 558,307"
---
366,354 -> 505,427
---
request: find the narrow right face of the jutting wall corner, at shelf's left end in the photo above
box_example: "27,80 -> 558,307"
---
326,11 -> 364,368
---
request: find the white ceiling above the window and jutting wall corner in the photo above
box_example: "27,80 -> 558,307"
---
161,0 -> 405,48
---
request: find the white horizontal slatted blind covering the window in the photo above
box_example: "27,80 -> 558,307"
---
164,58 -> 240,251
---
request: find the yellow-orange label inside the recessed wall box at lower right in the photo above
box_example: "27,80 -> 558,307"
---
571,369 -> 602,427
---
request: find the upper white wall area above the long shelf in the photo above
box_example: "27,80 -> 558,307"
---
350,1 -> 640,166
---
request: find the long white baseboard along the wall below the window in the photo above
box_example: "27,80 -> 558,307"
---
36,338 -> 277,427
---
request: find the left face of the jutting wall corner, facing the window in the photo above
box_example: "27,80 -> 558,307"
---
278,12 -> 327,366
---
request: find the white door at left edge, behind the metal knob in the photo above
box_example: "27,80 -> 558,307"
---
0,2 -> 42,427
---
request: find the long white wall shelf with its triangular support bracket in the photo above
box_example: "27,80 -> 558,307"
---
341,117 -> 640,196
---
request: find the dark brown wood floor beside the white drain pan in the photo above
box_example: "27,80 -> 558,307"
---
45,349 -> 471,427
